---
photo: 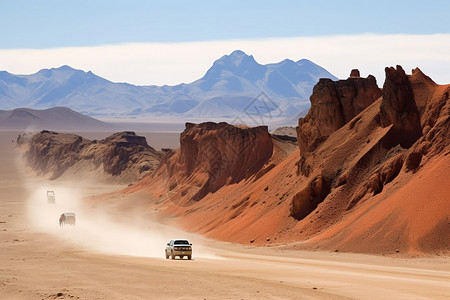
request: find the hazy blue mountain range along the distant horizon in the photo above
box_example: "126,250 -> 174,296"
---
0,50 -> 337,123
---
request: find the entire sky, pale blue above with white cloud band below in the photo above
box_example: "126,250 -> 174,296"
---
0,0 -> 450,85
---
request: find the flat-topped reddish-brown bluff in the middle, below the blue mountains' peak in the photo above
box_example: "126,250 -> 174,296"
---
158,122 -> 273,200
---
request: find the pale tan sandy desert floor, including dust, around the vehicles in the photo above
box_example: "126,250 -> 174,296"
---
0,132 -> 450,299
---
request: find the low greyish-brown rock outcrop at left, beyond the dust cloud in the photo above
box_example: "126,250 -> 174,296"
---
25,130 -> 161,183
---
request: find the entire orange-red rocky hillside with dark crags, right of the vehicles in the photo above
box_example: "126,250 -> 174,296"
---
120,66 -> 450,255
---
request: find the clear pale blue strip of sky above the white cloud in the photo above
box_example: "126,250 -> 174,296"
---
0,0 -> 450,49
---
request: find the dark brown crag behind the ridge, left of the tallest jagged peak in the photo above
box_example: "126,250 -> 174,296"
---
297,70 -> 381,156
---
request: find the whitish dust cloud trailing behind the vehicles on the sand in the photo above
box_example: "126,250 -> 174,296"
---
28,182 -> 219,259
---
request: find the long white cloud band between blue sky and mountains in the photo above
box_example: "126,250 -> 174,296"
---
0,34 -> 450,86
